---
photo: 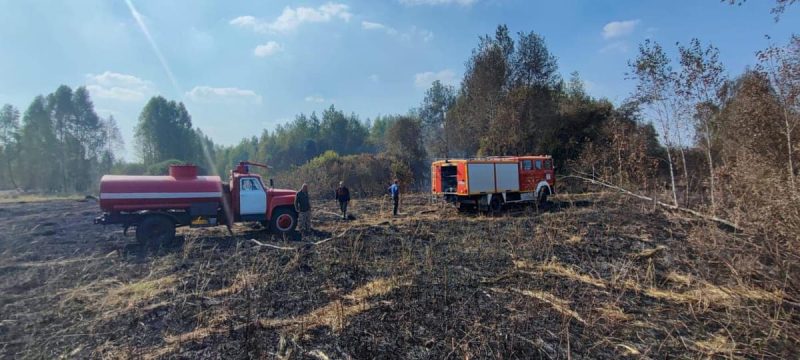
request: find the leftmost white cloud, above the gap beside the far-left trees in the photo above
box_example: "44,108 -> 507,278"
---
86,71 -> 154,101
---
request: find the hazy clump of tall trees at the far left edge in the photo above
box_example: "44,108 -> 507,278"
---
0,85 -> 122,193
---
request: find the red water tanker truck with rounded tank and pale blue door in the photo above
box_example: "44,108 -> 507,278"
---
95,161 -> 297,243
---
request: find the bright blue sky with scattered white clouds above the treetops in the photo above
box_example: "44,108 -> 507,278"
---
0,0 -> 800,159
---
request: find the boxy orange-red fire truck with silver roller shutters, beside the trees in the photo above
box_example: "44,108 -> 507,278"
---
431,155 -> 555,211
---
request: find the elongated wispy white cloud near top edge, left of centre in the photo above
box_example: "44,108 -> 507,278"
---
230,2 -> 353,33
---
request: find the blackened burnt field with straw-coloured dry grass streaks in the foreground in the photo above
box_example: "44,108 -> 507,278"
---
0,193 -> 798,359
